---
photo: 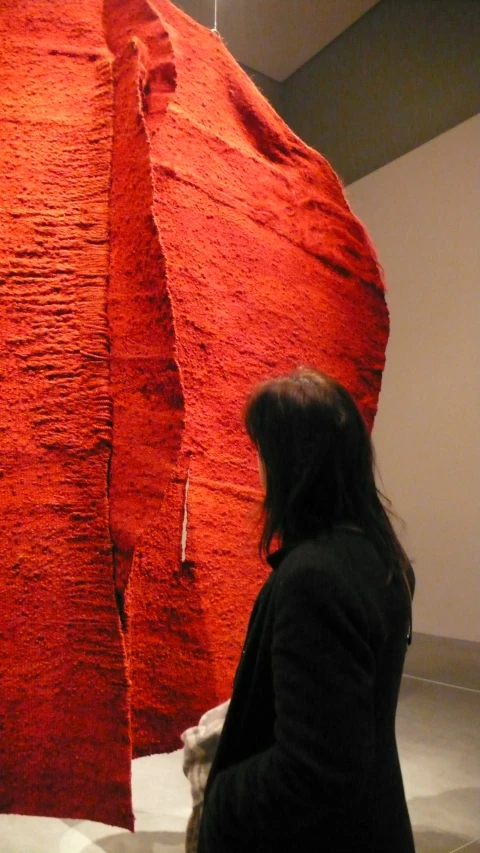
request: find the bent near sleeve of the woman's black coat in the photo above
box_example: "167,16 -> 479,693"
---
202,565 -> 375,853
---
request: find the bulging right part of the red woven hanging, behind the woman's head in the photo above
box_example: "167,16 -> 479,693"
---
105,0 -> 388,754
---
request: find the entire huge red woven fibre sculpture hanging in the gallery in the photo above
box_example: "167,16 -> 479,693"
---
0,0 -> 388,828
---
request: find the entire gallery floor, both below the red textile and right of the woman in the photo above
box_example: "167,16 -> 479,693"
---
0,634 -> 480,853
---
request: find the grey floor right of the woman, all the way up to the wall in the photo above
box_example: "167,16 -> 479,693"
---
397,634 -> 480,853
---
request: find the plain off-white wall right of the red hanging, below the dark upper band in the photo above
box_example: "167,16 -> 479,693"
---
347,115 -> 480,641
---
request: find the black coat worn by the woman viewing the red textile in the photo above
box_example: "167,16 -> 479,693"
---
199,529 -> 415,853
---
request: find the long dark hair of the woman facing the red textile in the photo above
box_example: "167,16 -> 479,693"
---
244,368 -> 409,583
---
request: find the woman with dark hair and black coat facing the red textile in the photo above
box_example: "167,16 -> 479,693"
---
198,369 -> 415,853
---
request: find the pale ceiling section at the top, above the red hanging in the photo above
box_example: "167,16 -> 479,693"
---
174,0 -> 378,82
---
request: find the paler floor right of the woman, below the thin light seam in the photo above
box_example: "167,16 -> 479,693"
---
397,676 -> 480,853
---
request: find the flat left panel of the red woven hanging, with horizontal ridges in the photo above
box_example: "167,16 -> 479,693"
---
0,0 -> 132,824
